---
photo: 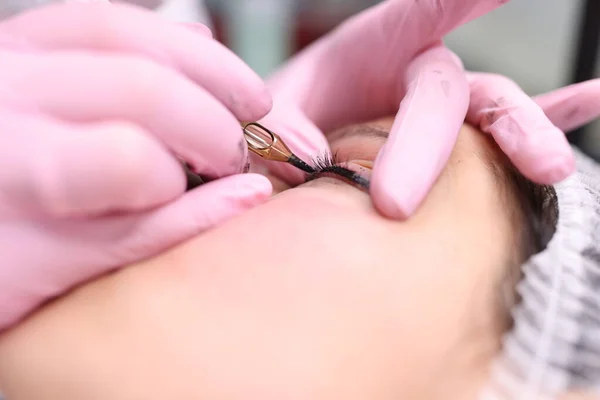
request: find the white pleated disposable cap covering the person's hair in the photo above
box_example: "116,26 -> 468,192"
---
481,148 -> 600,400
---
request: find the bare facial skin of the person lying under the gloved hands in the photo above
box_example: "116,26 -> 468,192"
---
0,119 -> 552,400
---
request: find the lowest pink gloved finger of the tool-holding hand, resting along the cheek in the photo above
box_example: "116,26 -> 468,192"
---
0,174 -> 271,330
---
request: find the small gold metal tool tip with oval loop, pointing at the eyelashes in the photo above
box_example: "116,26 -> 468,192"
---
242,122 -> 315,174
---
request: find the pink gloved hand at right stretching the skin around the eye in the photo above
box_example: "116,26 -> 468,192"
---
264,0 -> 574,218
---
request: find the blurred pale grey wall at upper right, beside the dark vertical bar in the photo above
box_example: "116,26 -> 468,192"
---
446,0 -> 580,94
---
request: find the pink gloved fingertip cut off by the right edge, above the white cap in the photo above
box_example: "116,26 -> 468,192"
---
533,79 -> 600,132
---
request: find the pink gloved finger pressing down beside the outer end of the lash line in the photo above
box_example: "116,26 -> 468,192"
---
371,46 -> 469,218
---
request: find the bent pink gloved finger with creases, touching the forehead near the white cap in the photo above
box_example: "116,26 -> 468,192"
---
467,73 -> 575,184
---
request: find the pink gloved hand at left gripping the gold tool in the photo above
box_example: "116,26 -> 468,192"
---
0,4 -> 271,330
